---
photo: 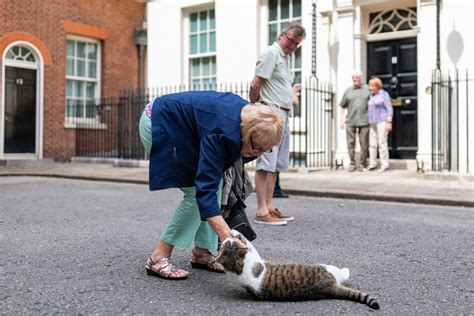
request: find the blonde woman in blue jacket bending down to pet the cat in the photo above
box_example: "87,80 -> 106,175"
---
140,91 -> 283,280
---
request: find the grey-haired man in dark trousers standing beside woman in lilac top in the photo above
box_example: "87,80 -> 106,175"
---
339,70 -> 370,172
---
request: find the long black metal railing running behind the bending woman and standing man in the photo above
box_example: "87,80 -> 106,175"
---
73,77 -> 334,167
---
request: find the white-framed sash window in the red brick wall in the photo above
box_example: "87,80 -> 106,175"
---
66,37 -> 100,122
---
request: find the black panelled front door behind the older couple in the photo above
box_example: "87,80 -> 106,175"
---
367,38 -> 418,159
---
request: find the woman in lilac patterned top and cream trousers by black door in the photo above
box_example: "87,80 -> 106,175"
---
368,77 -> 393,172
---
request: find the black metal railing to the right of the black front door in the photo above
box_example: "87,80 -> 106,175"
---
431,70 -> 474,173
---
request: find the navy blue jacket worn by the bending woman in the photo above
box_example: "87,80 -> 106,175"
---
150,91 -> 249,220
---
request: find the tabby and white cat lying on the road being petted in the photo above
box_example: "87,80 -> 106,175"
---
217,230 -> 379,309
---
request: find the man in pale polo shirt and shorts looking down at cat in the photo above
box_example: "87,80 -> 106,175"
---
250,23 -> 306,225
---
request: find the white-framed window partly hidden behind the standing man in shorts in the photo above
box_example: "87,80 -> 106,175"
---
268,0 -> 302,116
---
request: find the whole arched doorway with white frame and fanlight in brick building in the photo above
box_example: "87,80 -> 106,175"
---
0,43 -> 41,158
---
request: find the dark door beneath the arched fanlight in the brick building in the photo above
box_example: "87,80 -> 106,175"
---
4,67 -> 36,154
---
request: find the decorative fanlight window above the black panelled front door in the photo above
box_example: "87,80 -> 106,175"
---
369,8 -> 417,34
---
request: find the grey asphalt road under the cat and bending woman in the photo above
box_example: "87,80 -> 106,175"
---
0,177 -> 474,315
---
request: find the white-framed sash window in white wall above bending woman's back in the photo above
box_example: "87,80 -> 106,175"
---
189,10 -> 217,90
